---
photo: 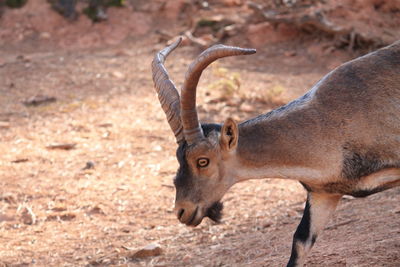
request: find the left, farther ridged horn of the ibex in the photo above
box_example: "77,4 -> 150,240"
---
151,38 -> 185,144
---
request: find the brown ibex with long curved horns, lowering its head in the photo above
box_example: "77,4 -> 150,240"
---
152,40 -> 400,266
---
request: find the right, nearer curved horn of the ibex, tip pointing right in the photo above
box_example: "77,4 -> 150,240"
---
181,45 -> 256,145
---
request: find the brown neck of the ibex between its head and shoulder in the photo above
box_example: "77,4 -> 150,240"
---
236,95 -> 332,184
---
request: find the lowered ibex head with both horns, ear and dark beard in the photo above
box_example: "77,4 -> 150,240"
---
152,39 -> 256,226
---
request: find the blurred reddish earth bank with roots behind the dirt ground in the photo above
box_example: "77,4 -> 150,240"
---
0,0 -> 400,51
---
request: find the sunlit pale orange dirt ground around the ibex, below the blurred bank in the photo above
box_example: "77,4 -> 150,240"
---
0,1 -> 400,267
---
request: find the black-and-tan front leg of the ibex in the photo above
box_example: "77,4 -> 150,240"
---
287,192 -> 342,267
